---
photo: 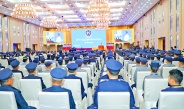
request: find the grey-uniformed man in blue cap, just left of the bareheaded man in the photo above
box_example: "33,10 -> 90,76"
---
142,61 -> 163,90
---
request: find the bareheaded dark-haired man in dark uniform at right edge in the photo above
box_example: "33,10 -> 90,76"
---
151,69 -> 184,109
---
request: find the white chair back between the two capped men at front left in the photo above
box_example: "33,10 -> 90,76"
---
20,79 -> 42,100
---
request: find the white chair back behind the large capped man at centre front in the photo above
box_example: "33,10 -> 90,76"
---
98,92 -> 130,109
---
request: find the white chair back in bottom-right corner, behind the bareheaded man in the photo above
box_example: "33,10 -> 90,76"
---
158,92 -> 184,109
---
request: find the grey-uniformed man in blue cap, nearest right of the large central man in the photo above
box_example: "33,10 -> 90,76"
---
131,58 -> 150,88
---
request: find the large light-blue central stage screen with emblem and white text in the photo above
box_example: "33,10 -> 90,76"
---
72,29 -> 106,48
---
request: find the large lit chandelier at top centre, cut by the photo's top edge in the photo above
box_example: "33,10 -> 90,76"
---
87,0 -> 111,16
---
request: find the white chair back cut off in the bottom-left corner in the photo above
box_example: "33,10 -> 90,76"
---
0,91 -> 18,109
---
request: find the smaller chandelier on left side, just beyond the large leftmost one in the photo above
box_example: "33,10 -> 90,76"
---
40,17 -> 57,28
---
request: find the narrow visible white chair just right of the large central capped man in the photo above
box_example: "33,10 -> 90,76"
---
133,71 -> 151,107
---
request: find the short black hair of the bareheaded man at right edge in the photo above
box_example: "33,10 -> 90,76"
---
169,69 -> 183,84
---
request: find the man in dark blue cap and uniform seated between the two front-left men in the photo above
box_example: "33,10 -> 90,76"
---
22,62 -> 46,89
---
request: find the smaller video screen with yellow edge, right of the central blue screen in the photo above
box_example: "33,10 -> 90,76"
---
113,29 -> 134,43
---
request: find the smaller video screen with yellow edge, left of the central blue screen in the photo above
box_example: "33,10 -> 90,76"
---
43,31 -> 64,44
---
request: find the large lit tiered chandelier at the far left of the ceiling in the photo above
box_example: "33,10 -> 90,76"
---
11,3 -> 38,20
